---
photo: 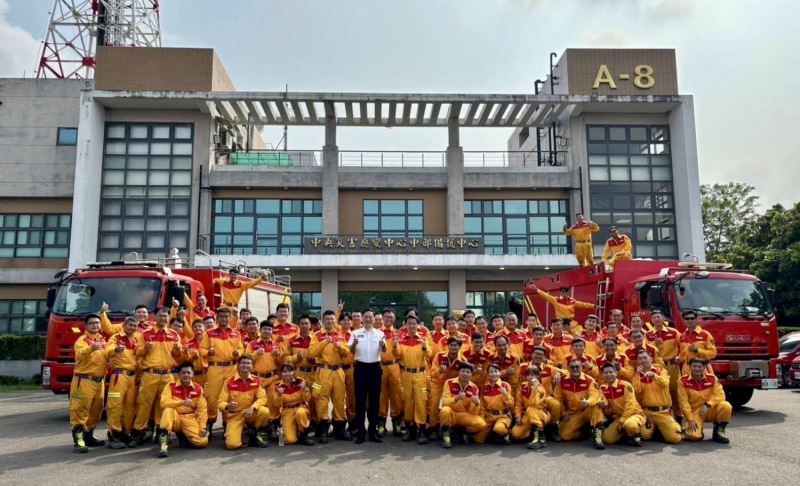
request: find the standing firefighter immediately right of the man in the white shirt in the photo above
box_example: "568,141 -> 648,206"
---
392,314 -> 433,444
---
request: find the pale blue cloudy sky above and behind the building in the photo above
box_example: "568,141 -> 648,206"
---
0,0 -> 800,206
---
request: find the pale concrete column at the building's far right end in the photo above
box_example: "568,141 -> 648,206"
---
669,96 -> 706,262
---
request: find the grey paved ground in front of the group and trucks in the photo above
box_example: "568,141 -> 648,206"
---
0,390 -> 800,486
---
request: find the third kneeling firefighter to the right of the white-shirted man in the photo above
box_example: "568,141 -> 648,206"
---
511,366 -> 550,450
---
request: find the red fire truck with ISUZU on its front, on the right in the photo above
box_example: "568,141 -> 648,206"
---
523,260 -> 781,407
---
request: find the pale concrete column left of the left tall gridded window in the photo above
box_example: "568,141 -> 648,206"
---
69,91 -> 106,270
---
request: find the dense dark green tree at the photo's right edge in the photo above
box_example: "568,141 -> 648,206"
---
729,203 -> 800,325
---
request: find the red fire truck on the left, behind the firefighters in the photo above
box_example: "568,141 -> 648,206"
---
42,260 -> 291,393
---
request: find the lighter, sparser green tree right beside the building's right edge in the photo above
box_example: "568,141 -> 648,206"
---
700,182 -> 758,261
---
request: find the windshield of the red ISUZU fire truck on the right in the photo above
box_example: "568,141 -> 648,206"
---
675,278 -> 772,316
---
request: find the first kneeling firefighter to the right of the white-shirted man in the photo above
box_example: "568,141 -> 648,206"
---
439,361 -> 486,449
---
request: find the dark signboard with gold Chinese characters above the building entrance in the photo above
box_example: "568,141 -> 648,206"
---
303,235 -> 484,255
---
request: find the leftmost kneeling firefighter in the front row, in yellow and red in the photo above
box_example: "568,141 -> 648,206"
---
158,361 -> 208,457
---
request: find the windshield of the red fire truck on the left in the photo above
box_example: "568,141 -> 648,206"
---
53,277 -> 161,316
